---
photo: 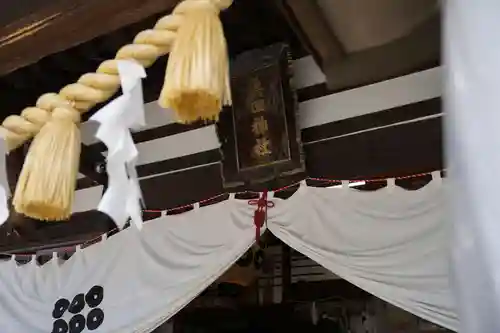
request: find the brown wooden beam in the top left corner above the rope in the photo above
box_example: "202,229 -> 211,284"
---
0,0 -> 179,75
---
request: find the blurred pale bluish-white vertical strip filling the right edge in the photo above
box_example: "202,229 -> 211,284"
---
443,0 -> 500,333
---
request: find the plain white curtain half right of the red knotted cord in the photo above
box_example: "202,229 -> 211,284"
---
268,181 -> 458,330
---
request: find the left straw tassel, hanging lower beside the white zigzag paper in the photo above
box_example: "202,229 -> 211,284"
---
13,106 -> 81,221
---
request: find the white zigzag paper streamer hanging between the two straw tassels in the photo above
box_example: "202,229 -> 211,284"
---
90,61 -> 146,229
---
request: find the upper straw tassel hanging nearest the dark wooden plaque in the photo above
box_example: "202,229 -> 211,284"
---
159,0 -> 232,123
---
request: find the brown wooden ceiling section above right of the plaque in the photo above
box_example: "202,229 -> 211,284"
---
276,0 -> 441,90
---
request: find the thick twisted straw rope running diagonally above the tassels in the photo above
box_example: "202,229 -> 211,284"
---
0,0 -> 232,151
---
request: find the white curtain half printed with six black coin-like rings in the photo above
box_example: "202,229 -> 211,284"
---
0,199 -> 255,333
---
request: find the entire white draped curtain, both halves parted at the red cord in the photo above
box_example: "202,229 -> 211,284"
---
0,182 -> 457,333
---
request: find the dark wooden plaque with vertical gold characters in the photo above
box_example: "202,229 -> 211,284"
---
218,44 -> 304,188
